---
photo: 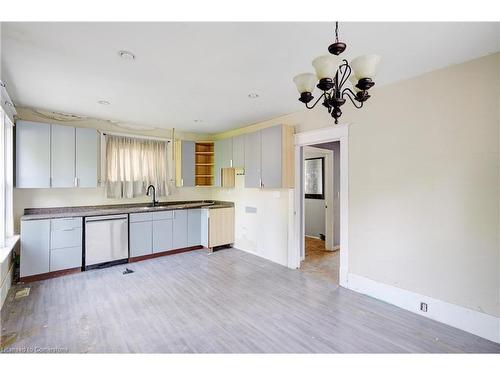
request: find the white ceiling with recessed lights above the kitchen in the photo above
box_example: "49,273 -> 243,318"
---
2,22 -> 500,133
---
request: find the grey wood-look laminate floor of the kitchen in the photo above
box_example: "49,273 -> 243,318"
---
1,249 -> 500,353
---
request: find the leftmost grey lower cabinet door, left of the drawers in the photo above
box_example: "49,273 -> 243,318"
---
21,219 -> 50,277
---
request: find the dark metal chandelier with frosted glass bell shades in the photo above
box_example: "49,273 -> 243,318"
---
293,22 -> 380,124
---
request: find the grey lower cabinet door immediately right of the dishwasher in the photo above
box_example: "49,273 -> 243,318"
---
129,212 -> 153,258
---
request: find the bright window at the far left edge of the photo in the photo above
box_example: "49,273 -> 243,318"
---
0,107 -> 14,247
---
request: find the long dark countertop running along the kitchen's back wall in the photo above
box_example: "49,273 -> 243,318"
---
21,201 -> 234,220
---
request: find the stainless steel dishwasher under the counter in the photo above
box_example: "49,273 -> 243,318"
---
85,215 -> 128,269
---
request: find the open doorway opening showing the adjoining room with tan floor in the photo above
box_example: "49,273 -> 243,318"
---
300,141 -> 340,285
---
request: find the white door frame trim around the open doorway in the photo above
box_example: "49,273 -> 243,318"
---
288,124 -> 349,288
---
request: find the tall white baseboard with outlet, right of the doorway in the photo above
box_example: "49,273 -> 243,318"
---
348,273 -> 500,343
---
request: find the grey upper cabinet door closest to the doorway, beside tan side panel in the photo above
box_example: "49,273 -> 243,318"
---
261,125 -> 283,188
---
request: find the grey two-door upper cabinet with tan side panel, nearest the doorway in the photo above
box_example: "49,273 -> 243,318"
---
245,125 -> 294,189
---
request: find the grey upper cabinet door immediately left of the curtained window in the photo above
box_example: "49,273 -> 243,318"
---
75,128 -> 98,187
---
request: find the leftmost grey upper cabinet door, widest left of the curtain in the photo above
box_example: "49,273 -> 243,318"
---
15,121 -> 50,188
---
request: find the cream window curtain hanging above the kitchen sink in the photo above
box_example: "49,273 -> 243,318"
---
106,135 -> 168,198
